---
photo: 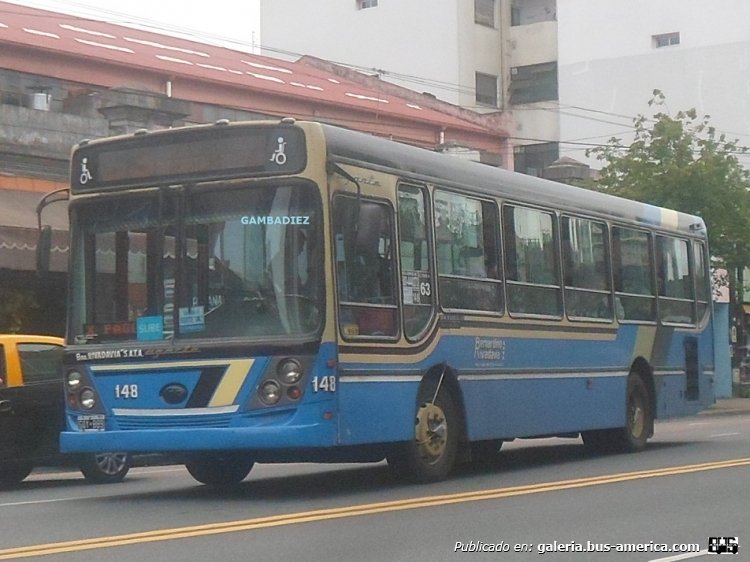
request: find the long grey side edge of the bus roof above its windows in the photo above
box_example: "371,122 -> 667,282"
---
322,124 -> 706,237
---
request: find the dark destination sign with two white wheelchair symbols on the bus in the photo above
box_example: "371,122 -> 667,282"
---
71,125 -> 307,194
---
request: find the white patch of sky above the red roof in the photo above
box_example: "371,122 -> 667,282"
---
6,0 -> 260,52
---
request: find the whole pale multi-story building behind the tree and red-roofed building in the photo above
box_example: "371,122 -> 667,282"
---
261,0 -> 750,175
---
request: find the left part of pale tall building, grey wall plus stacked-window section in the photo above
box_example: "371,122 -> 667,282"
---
261,0 -> 560,175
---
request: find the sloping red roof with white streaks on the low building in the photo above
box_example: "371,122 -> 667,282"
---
0,2 -> 498,135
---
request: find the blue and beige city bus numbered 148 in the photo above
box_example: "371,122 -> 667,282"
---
61,118 -> 714,485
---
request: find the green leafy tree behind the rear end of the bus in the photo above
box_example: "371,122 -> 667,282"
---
585,90 -> 750,267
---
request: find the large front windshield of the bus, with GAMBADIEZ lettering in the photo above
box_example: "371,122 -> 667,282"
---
69,182 -> 324,344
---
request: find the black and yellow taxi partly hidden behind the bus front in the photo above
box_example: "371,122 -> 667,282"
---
0,335 -> 131,486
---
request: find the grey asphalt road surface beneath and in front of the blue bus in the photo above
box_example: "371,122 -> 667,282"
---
0,414 -> 750,562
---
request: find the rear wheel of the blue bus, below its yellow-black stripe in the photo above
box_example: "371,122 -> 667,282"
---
581,375 -> 654,453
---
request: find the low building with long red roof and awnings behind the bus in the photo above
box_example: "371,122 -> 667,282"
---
0,1 -> 510,334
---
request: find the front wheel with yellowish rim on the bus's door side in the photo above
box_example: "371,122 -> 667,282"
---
388,384 -> 459,483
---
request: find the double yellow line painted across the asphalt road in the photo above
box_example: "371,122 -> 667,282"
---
0,457 -> 750,560
